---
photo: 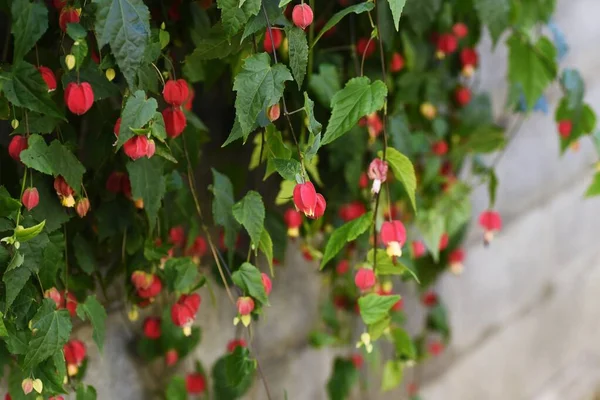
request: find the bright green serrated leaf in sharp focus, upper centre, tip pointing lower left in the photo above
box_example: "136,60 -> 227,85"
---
321,76 -> 387,145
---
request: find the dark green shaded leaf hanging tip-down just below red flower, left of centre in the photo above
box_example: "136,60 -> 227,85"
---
127,157 -> 166,227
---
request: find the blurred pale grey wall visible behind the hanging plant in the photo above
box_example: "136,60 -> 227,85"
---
48,0 -> 600,400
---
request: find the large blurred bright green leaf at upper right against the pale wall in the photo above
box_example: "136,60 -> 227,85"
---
510,33 -> 557,110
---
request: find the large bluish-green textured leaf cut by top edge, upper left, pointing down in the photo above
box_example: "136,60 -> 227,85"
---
93,0 -> 150,87
